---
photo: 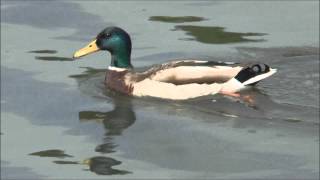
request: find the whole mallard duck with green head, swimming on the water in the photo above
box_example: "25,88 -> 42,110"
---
73,27 -> 276,100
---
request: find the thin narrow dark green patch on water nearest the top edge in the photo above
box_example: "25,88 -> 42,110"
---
149,16 -> 206,23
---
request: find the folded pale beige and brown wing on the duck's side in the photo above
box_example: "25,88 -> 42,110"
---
148,60 -> 243,85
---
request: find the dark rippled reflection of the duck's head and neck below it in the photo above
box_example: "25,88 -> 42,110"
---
79,97 -> 136,175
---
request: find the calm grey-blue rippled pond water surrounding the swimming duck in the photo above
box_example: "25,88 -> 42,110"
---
1,0 -> 319,179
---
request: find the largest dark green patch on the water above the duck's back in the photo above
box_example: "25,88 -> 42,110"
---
173,25 -> 266,44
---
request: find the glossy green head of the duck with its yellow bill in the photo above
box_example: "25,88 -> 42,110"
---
73,27 -> 132,68
